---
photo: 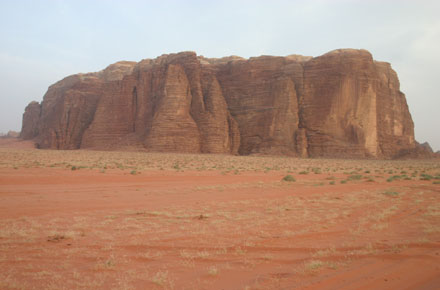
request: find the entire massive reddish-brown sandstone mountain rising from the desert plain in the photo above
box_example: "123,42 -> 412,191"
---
21,49 -> 418,158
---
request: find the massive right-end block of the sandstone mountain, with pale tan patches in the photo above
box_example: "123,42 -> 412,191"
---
301,50 -> 415,157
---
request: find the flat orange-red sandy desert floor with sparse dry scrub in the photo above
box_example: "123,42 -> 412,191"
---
0,142 -> 440,289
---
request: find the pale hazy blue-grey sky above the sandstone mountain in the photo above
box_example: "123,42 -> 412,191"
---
0,0 -> 440,150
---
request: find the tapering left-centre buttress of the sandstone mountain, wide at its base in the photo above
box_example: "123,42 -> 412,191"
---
80,53 -> 240,154
